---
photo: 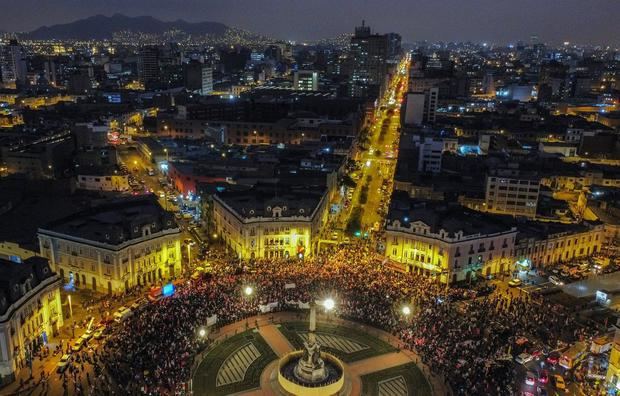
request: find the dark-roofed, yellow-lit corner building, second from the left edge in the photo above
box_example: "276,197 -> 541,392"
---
38,196 -> 181,293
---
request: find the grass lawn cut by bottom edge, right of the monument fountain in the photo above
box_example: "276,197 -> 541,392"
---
362,363 -> 432,396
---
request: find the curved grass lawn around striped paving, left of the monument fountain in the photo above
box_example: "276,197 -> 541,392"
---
193,330 -> 278,396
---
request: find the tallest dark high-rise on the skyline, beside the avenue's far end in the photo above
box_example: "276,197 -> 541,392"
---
349,21 -> 388,97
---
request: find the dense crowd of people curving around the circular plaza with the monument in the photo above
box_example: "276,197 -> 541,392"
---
99,245 -> 592,395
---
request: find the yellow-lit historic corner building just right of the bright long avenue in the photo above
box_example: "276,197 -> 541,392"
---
385,191 -> 517,283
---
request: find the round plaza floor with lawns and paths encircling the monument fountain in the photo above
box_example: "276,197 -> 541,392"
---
192,313 -> 449,396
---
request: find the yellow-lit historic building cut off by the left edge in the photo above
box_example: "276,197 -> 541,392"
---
0,256 -> 63,387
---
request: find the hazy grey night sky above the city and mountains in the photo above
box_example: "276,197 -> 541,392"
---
0,0 -> 620,46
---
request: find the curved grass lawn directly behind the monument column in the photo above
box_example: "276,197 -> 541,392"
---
279,322 -> 396,363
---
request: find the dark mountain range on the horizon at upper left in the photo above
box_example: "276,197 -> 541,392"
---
26,14 -> 228,40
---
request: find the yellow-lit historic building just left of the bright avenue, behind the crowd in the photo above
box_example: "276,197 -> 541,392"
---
212,186 -> 328,259
